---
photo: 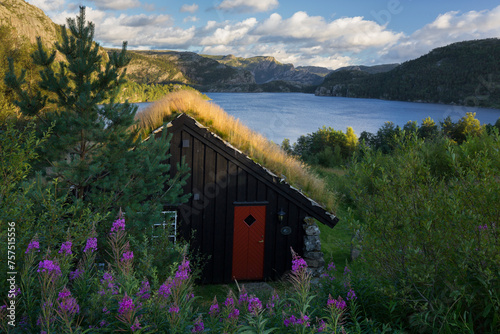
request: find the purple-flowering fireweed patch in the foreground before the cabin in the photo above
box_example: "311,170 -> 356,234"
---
0,218 -> 398,334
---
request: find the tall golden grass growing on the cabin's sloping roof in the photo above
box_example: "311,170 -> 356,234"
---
136,91 -> 335,211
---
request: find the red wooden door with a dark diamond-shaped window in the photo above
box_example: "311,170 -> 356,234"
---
232,206 -> 266,280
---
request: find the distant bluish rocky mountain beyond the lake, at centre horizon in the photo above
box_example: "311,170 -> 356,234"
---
204,55 -> 328,87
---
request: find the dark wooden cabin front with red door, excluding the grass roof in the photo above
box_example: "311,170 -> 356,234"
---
155,114 -> 338,283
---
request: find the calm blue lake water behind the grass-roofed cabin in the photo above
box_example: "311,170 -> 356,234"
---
136,93 -> 500,143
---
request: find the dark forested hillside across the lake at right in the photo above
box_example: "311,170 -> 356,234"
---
316,38 -> 500,108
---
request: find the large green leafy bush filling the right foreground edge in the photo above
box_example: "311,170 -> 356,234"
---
348,132 -> 500,332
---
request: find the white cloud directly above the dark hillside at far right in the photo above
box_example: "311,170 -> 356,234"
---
382,6 -> 500,61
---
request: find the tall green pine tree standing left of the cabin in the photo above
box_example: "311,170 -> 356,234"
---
5,7 -> 187,229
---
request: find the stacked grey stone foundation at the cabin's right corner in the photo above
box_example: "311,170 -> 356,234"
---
303,217 -> 325,278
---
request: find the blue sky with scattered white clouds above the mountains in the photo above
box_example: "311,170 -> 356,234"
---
27,0 -> 500,69
